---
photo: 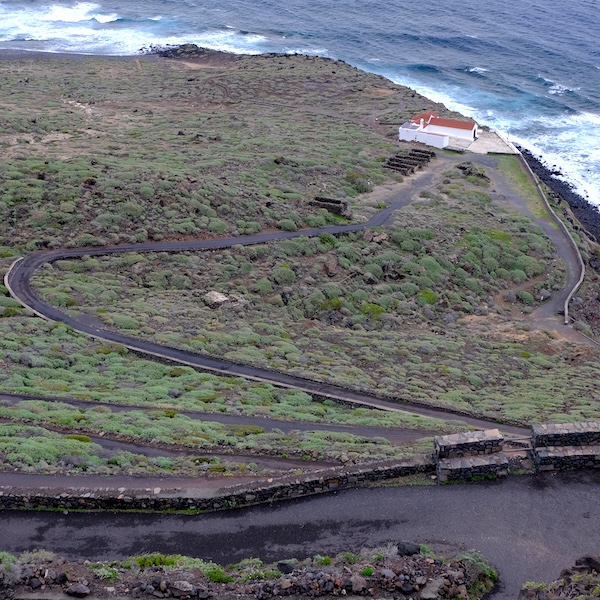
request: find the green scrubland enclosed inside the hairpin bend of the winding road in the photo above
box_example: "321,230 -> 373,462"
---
30,162 -> 600,423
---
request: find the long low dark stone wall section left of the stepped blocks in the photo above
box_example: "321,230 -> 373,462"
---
0,458 -> 435,511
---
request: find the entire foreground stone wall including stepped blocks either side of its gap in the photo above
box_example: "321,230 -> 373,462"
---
0,423 -> 600,511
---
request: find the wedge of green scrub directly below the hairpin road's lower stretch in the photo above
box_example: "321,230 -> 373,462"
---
0,282 -> 461,431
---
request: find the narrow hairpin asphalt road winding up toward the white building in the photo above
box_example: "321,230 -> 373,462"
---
5,157 -> 527,435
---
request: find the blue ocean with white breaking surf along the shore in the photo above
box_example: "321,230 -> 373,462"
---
0,0 -> 600,206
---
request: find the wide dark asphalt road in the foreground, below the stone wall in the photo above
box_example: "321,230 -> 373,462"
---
0,472 -> 600,600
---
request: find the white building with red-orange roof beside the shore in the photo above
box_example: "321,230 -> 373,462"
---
398,110 -> 477,148
